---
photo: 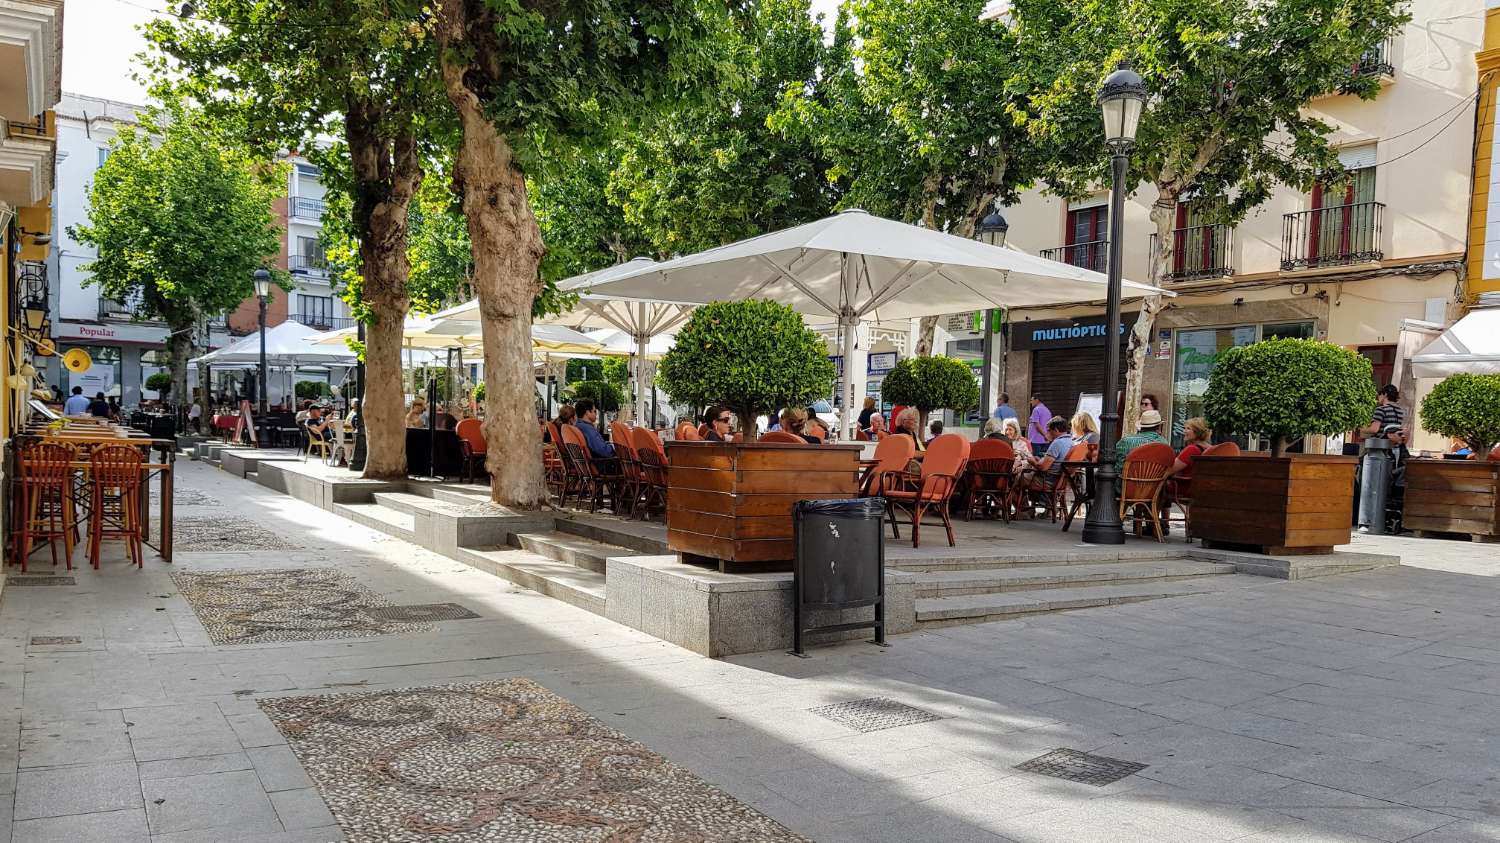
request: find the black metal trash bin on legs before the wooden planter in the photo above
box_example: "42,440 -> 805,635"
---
792,498 -> 885,656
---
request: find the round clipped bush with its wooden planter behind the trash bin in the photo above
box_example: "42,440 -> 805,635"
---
657,300 -> 860,572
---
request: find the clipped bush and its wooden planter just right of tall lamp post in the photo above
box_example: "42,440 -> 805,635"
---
1188,339 -> 1376,555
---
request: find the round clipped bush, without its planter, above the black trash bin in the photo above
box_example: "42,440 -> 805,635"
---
657,299 -> 834,443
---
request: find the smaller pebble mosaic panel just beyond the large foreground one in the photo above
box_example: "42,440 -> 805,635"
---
173,569 -> 432,644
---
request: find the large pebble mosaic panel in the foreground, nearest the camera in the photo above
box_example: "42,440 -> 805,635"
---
260,680 -> 806,843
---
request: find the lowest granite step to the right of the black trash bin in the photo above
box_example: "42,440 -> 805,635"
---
917,575 -> 1268,627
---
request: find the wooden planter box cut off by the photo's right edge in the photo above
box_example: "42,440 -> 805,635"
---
1401,459 -> 1500,542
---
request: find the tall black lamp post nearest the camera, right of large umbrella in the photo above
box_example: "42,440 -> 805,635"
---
1083,62 -> 1146,545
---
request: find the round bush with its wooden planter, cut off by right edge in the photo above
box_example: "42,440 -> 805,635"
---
1401,374 -> 1500,542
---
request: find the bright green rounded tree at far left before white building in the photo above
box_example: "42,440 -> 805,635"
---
69,102 -> 290,408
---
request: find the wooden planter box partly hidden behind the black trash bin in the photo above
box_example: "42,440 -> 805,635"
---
666,443 -> 861,573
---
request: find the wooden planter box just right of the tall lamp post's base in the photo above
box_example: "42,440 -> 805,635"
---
1188,455 -> 1358,555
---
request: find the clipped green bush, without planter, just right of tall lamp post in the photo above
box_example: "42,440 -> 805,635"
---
1203,339 -> 1376,456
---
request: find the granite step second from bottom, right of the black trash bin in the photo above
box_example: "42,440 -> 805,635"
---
914,560 -> 1235,597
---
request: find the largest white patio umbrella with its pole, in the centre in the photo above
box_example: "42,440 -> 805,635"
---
573,210 -> 1172,435
